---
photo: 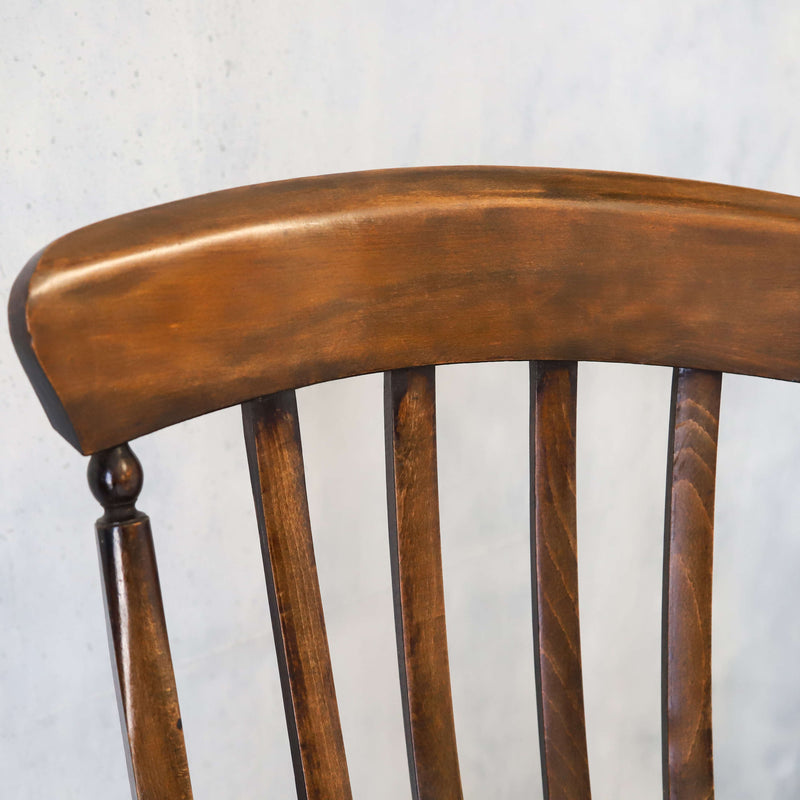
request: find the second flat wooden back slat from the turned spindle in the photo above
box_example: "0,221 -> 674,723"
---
384,367 -> 462,800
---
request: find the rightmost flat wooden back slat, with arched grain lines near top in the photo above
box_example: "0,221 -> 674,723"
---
662,369 -> 722,800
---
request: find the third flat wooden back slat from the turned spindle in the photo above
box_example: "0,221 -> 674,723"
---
531,361 -> 591,800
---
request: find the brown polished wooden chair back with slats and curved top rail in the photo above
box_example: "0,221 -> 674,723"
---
10,167 -> 800,800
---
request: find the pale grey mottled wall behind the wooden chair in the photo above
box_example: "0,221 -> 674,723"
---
0,0 -> 800,800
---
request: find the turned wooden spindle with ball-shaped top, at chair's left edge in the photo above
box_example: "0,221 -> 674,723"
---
89,445 -> 192,800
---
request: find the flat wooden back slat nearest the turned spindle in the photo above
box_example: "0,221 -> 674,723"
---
242,391 -> 351,800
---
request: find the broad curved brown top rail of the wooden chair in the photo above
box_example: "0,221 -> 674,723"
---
10,167 -> 800,453
